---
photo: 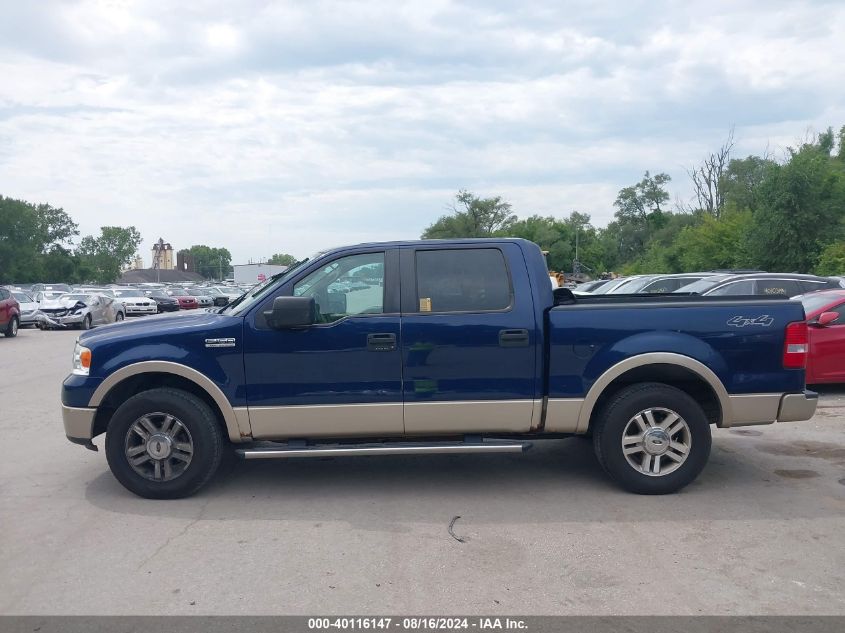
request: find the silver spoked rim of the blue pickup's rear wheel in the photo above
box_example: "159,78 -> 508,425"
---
622,407 -> 692,477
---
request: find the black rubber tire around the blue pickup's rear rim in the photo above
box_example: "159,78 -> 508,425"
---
591,383 -> 712,495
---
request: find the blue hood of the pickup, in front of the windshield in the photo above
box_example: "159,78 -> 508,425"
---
79,310 -> 236,345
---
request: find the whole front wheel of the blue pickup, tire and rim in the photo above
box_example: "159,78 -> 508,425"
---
106,388 -> 223,499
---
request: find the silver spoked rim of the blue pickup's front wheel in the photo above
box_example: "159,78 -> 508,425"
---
124,412 -> 194,482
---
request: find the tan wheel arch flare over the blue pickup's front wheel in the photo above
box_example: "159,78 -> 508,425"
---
88,361 -> 252,442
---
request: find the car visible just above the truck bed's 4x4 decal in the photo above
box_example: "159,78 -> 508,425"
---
675,273 -> 840,297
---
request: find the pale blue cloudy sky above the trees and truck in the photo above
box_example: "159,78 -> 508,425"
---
0,0 -> 845,265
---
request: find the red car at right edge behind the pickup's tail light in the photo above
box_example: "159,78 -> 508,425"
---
798,289 -> 845,385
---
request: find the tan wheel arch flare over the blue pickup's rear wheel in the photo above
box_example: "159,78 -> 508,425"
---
575,352 -> 731,433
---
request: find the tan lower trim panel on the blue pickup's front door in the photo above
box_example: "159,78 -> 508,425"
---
249,402 -> 403,440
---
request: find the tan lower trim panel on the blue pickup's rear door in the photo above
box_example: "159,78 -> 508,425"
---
404,400 -> 541,435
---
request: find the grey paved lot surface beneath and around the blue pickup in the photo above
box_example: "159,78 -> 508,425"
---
0,330 -> 845,615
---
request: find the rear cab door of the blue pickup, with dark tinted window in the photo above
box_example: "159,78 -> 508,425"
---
401,242 -> 536,434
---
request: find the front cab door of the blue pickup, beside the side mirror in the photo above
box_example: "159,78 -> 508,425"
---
244,248 -> 403,439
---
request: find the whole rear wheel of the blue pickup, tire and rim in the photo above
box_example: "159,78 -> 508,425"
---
593,383 -> 711,494
